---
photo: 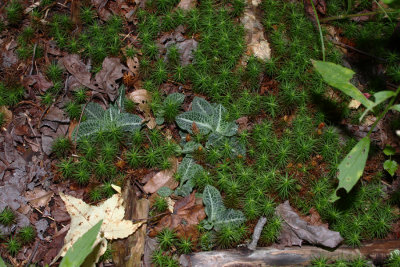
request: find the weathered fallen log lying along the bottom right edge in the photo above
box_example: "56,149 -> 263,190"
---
179,240 -> 400,267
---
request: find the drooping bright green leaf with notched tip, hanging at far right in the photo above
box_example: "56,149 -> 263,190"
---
331,137 -> 371,202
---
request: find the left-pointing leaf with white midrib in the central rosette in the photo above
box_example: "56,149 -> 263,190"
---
175,111 -> 213,134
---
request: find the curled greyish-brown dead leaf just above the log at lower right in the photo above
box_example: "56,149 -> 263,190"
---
275,201 -> 343,248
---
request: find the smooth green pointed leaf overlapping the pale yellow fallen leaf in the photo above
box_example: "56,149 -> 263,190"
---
60,220 -> 103,267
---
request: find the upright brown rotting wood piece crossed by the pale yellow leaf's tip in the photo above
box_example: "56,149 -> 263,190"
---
112,181 -> 149,267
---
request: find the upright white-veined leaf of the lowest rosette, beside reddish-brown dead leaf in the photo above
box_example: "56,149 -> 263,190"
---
203,185 -> 226,223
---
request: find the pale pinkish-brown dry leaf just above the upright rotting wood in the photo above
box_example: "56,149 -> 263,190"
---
143,158 -> 178,194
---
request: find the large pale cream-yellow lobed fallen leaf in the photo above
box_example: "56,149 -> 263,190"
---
53,188 -> 143,262
